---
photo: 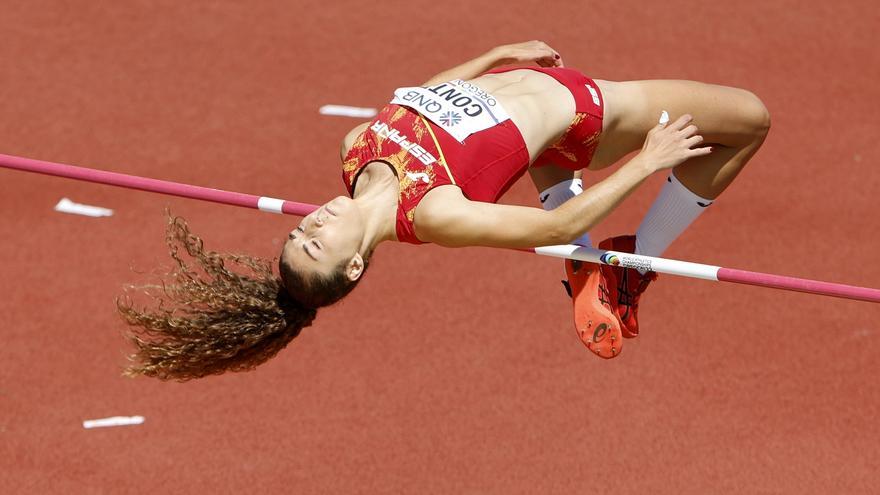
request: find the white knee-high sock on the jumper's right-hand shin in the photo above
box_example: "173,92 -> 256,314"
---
636,173 -> 713,256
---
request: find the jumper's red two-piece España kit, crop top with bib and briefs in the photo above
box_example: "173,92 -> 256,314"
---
342,67 -> 602,244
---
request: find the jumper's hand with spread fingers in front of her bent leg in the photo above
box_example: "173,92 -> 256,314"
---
640,114 -> 712,170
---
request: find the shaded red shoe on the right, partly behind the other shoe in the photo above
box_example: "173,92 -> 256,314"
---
599,235 -> 657,339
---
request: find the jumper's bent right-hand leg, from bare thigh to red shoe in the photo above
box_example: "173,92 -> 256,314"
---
591,81 -> 770,337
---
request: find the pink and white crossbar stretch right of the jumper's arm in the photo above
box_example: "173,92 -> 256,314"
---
534,245 -> 880,302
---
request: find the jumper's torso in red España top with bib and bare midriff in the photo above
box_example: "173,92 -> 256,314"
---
343,70 -> 575,243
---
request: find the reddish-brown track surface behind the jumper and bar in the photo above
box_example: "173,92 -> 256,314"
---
0,0 -> 880,494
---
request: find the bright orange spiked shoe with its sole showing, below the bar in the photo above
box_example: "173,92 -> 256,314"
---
563,260 -> 623,359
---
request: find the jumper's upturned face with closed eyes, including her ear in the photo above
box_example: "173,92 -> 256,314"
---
281,196 -> 364,279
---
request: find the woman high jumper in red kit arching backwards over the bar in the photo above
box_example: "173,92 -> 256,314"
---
118,41 -> 770,380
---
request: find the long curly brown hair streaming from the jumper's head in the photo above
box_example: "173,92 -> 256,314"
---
116,215 -> 320,381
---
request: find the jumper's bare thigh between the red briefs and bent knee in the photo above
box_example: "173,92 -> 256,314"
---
590,80 -> 769,169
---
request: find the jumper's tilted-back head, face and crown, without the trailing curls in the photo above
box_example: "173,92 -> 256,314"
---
279,196 -> 369,308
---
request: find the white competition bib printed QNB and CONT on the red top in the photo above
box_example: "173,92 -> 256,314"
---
391,79 -> 510,143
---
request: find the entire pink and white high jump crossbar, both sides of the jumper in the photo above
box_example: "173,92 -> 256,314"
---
0,154 -> 880,303
